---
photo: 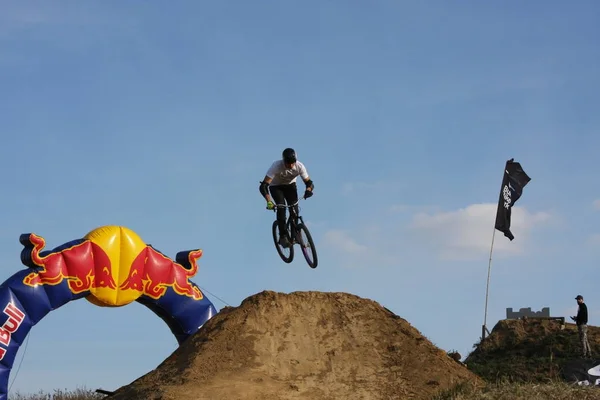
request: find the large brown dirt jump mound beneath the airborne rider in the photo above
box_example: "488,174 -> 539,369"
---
110,291 -> 482,400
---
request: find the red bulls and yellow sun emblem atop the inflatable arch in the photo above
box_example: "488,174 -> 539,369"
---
23,226 -> 204,307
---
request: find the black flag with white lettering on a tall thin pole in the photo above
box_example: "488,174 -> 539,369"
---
496,158 -> 531,241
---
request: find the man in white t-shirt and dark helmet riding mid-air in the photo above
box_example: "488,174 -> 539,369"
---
259,148 -> 314,247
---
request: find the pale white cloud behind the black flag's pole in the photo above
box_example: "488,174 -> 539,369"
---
411,203 -> 550,260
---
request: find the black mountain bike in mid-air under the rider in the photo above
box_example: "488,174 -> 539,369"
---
273,199 -> 318,268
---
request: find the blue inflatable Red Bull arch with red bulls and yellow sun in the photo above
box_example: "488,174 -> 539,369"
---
0,225 -> 216,400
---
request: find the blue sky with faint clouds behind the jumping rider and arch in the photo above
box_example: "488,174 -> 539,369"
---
0,1 -> 600,392
